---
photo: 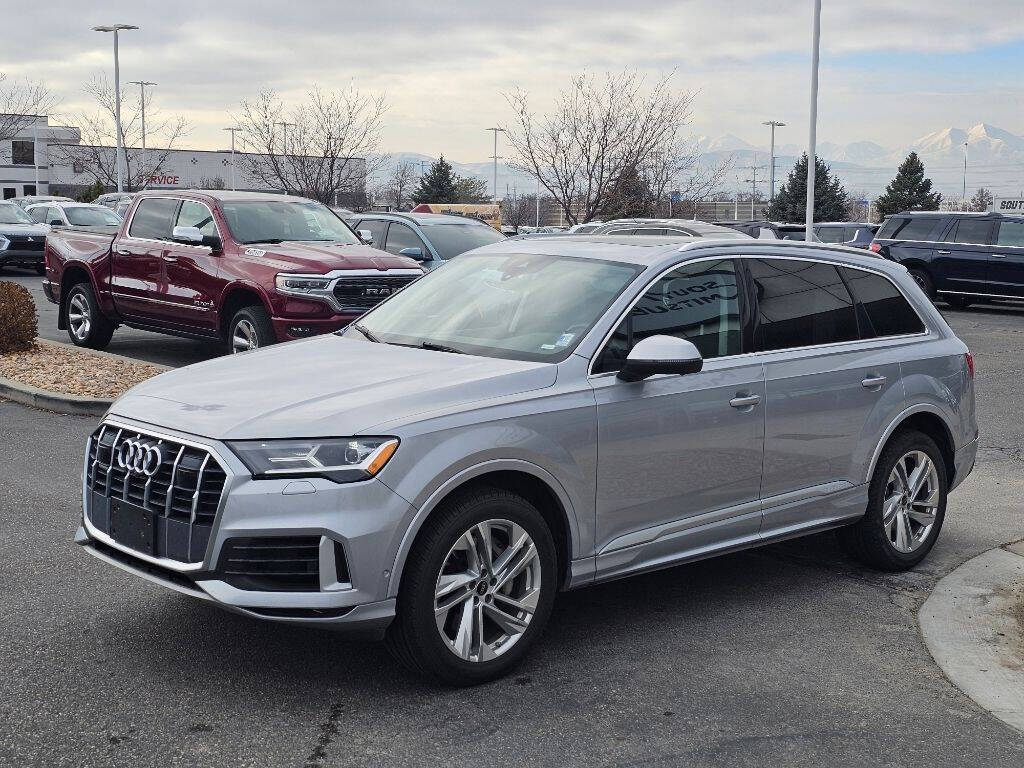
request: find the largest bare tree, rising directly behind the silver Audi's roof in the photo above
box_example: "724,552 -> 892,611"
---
506,71 -> 712,223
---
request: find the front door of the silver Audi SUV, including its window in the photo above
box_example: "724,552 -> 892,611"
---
591,259 -> 765,579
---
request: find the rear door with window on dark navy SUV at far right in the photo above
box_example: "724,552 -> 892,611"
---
932,216 -> 995,294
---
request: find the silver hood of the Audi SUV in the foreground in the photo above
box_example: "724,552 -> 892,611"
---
111,335 -> 556,439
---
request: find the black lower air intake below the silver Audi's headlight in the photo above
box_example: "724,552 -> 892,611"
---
217,536 -> 321,592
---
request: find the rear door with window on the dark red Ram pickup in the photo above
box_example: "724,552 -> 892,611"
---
111,198 -> 180,323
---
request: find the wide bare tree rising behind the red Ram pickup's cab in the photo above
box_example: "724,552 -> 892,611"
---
236,87 -> 387,203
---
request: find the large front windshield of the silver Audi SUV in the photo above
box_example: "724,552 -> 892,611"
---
343,250 -> 641,362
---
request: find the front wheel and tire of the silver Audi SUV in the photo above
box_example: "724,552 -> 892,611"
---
387,487 -> 558,686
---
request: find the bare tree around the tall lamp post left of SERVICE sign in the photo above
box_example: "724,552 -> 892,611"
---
50,75 -> 189,189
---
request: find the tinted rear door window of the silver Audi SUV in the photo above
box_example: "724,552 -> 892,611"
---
749,259 -> 858,350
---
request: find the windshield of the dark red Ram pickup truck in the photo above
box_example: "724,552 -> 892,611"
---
220,200 -> 359,246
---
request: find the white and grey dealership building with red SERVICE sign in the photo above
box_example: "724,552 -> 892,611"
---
0,115 -> 366,203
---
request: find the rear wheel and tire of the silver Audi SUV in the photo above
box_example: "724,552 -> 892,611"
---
839,429 -> 948,570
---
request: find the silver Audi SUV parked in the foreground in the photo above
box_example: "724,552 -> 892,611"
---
77,236 -> 978,684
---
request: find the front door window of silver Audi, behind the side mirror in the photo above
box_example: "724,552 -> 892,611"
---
594,259 -> 743,374
